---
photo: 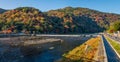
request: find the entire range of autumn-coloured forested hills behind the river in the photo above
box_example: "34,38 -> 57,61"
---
0,7 -> 120,34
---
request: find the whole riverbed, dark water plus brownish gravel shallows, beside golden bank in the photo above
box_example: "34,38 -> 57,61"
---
0,37 -> 91,62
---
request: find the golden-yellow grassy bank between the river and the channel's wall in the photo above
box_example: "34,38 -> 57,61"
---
62,37 -> 100,62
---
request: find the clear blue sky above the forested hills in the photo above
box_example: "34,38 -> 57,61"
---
0,0 -> 120,14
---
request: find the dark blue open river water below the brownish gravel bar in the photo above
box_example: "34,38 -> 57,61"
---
0,37 -> 90,62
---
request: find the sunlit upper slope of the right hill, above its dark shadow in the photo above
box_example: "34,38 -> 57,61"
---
48,7 -> 120,29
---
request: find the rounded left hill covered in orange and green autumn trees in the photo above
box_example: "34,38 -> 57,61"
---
0,7 -> 47,33
